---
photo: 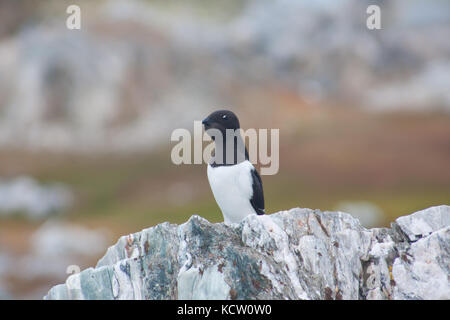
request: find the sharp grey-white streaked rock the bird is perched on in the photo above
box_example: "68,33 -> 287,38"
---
45,206 -> 450,299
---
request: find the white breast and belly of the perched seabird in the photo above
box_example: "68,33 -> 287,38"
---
208,161 -> 256,223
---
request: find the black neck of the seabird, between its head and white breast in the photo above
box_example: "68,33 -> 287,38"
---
210,135 -> 248,167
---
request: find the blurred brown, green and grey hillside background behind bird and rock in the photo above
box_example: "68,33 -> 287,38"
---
0,0 -> 450,299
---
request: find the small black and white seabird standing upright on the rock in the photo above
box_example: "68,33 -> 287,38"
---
202,110 -> 265,223
